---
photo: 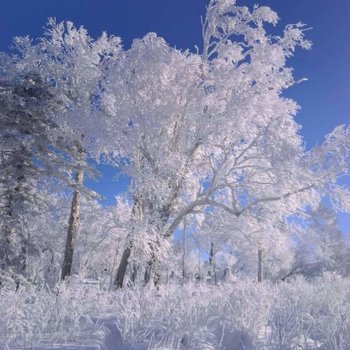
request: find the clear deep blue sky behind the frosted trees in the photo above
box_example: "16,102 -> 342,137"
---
0,0 -> 350,229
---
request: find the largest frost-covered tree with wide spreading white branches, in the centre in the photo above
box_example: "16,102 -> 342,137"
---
101,0 -> 348,286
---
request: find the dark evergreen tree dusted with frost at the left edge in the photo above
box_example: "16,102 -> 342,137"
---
0,56 -> 69,277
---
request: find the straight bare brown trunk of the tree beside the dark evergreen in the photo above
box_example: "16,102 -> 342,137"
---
61,165 -> 84,281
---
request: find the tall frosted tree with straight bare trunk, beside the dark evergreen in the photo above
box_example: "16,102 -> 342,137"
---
12,19 -> 121,279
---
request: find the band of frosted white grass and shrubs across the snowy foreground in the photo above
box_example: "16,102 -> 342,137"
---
0,274 -> 350,350
